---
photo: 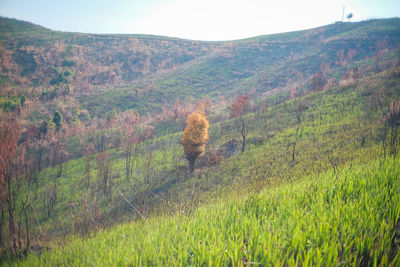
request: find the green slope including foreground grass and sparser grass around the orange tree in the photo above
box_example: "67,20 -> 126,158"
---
5,64 -> 400,266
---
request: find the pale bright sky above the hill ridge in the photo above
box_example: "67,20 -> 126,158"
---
0,0 -> 400,41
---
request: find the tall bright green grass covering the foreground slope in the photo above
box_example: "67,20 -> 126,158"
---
15,158 -> 400,266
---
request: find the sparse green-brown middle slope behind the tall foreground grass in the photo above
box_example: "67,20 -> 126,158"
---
0,69 -> 400,266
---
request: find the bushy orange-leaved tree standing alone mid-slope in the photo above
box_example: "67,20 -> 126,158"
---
182,107 -> 209,173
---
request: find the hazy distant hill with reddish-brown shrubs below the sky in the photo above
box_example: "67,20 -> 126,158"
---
0,18 -> 400,117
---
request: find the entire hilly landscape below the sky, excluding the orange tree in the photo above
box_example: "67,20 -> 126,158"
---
0,18 -> 400,266
